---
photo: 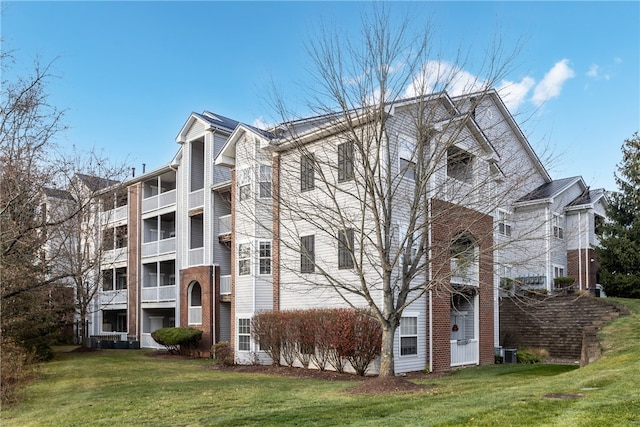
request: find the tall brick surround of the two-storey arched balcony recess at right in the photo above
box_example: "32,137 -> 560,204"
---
431,199 -> 494,371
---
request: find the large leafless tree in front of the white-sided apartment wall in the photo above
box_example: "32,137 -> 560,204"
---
245,9 -> 546,376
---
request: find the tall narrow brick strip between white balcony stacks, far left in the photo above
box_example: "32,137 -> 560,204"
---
127,183 -> 142,341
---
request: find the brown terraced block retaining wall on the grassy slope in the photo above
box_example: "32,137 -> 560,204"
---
500,295 -> 629,366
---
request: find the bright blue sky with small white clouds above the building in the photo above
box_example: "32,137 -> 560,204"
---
0,1 -> 640,189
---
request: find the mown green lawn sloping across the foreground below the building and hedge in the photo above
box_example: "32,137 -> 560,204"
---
0,300 -> 640,427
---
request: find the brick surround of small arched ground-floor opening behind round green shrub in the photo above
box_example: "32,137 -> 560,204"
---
180,265 -> 215,355
